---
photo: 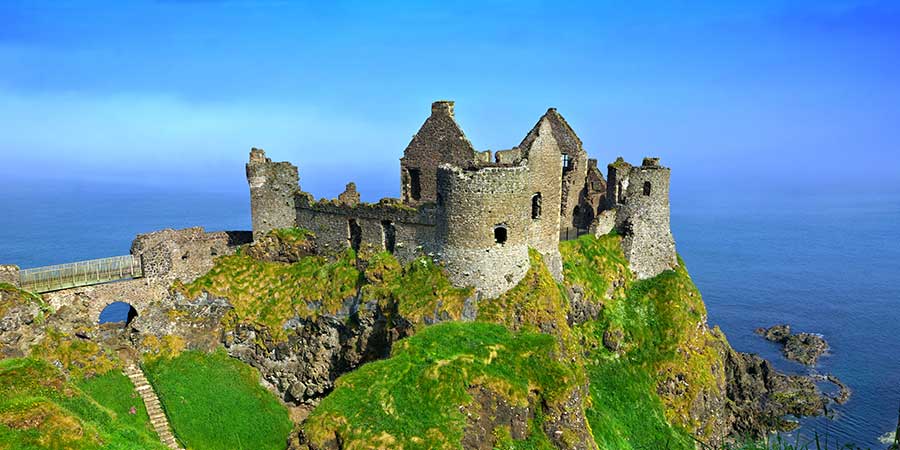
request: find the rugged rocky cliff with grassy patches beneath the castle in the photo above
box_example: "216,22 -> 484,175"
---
0,233 -> 823,450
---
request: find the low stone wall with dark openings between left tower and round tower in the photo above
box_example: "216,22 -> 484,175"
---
296,193 -> 434,263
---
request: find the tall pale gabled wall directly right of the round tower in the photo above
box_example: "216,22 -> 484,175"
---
518,115 -> 562,281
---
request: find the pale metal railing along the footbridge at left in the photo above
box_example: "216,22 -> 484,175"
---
19,255 -> 144,293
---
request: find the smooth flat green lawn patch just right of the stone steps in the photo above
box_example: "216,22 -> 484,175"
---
144,350 -> 293,450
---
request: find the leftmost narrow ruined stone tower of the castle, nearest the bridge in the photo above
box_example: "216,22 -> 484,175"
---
247,148 -> 300,236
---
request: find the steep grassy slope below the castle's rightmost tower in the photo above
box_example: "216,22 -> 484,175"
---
561,235 -> 721,449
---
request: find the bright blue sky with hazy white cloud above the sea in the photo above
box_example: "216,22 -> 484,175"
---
0,0 -> 900,200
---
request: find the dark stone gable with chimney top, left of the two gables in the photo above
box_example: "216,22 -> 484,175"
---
400,101 -> 483,206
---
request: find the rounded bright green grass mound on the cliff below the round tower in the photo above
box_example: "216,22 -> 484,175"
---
304,323 -> 576,449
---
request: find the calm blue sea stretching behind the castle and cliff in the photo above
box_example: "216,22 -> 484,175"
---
0,182 -> 900,449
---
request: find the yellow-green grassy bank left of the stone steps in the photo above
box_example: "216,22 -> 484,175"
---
0,358 -> 166,450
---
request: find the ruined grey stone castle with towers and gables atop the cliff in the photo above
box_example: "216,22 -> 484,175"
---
247,101 -> 677,298
